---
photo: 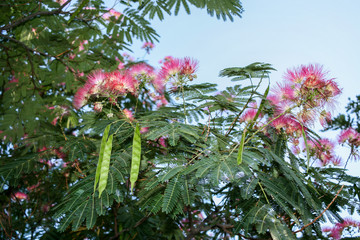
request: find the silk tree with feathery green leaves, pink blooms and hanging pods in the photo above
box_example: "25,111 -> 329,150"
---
0,0 -> 360,239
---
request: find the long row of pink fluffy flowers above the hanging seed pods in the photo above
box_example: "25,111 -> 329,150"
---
73,58 -> 197,111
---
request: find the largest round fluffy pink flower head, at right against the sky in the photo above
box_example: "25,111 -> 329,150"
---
268,64 -> 341,126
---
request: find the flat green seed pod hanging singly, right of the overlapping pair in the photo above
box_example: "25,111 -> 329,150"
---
130,123 -> 141,193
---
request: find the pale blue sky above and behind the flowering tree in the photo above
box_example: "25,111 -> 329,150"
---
121,0 -> 360,176
